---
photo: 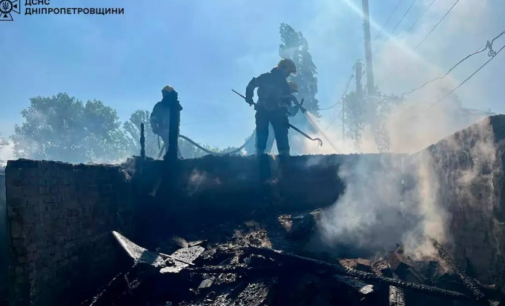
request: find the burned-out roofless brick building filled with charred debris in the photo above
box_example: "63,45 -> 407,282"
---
5,116 -> 505,306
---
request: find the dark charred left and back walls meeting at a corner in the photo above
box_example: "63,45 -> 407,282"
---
1,155 -> 358,305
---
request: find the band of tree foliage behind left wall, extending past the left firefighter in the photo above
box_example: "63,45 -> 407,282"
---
9,93 -> 238,163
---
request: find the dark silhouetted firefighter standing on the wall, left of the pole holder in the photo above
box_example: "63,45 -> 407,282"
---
150,86 -> 182,161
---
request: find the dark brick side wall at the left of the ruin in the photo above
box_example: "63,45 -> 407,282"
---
6,160 -> 131,306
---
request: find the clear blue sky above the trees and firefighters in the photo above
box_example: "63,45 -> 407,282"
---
0,0 -> 505,147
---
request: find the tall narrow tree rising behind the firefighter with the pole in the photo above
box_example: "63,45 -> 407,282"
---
279,23 -> 319,117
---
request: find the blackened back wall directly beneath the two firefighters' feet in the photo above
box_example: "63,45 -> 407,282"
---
136,155 -> 354,244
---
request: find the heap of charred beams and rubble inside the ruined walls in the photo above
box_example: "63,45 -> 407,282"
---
82,212 -> 501,306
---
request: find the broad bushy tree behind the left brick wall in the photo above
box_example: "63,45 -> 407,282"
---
11,93 -> 126,163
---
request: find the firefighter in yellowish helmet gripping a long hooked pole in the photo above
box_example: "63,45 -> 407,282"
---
246,59 -> 296,156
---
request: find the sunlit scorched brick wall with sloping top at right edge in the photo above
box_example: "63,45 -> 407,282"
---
416,115 -> 505,284
